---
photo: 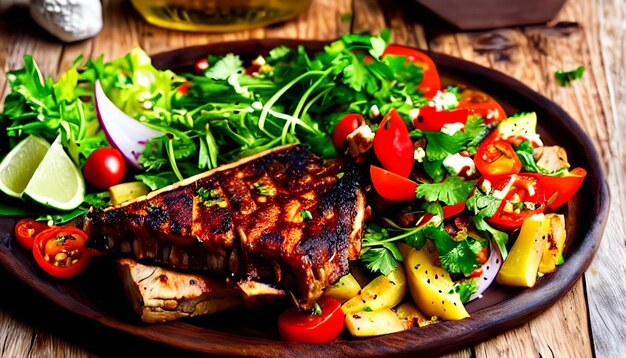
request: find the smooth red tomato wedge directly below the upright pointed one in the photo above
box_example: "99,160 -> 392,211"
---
370,165 -> 417,201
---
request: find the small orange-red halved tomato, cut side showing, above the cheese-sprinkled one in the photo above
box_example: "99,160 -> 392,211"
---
474,133 -> 522,178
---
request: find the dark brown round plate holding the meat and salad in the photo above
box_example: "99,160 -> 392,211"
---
0,40 -> 609,356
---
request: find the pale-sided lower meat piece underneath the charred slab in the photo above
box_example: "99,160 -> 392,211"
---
117,258 -> 242,323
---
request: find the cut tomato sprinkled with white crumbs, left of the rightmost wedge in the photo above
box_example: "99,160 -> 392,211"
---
487,174 -> 546,231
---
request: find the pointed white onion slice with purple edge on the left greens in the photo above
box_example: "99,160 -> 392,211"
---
94,80 -> 164,168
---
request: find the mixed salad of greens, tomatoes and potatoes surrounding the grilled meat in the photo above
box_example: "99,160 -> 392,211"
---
0,31 -> 586,342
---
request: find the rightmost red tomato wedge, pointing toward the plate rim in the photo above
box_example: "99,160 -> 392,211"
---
524,168 -> 587,210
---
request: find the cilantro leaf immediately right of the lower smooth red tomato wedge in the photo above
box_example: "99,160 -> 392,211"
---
415,175 -> 476,205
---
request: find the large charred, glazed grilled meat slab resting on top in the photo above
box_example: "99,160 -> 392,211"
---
86,145 -> 365,308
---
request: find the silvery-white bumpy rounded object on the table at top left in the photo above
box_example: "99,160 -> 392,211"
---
30,0 -> 102,42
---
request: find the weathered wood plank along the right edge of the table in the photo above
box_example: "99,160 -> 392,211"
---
585,0 -> 626,357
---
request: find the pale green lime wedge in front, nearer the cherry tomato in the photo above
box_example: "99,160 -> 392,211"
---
24,138 -> 85,210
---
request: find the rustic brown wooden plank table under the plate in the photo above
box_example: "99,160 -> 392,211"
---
0,0 -> 626,357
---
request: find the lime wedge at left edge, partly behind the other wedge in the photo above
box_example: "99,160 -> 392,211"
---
0,135 -> 50,198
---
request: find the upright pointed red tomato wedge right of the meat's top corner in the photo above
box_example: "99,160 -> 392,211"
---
374,109 -> 415,177
